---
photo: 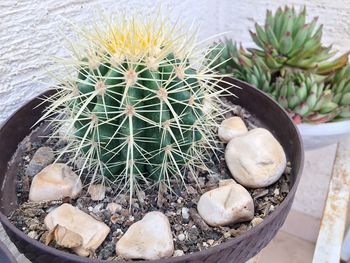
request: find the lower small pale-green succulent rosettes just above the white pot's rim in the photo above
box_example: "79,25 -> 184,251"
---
272,67 -> 350,123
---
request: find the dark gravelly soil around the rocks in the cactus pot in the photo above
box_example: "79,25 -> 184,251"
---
9,102 -> 290,260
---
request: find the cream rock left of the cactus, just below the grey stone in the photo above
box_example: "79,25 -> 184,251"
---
29,163 -> 82,202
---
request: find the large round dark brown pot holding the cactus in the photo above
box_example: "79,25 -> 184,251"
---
0,78 -> 304,263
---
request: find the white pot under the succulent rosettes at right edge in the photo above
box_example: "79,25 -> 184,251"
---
297,120 -> 350,150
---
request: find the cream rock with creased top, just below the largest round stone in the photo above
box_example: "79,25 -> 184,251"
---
197,183 -> 254,226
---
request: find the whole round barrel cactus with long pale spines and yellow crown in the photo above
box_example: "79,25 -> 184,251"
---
43,12 -> 225,196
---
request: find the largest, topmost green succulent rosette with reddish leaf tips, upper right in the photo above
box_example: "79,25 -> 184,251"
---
250,6 -> 348,74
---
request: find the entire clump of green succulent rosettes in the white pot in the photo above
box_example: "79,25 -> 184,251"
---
208,6 -> 350,123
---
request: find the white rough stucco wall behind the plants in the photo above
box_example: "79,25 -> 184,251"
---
0,0 -> 350,123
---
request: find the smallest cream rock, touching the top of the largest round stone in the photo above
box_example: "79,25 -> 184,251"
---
218,116 -> 248,143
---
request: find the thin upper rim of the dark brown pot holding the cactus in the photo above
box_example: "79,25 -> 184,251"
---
0,77 -> 304,263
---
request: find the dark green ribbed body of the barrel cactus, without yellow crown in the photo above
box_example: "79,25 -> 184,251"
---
74,54 -> 203,180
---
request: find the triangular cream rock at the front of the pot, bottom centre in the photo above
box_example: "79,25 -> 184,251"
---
116,212 -> 174,260
